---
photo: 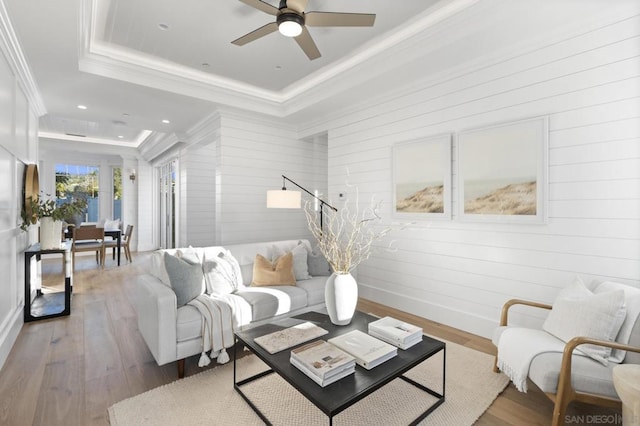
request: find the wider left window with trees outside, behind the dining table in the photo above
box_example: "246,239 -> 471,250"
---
56,164 -> 100,225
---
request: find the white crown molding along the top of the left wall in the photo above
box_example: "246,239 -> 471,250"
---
0,0 -> 47,117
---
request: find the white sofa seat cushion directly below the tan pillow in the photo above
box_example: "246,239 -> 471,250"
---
235,286 -> 307,321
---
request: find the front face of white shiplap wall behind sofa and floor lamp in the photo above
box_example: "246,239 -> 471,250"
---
204,113 -> 327,244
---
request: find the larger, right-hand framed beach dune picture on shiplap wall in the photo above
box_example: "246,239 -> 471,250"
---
457,117 -> 549,223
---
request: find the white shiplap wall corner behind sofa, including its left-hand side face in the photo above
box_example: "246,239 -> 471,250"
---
180,111 -> 327,246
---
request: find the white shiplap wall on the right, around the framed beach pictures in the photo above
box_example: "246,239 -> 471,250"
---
318,8 -> 640,337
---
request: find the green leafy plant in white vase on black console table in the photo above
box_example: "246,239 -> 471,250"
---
20,197 -> 87,250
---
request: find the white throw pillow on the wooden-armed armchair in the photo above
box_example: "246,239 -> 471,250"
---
542,277 -> 626,365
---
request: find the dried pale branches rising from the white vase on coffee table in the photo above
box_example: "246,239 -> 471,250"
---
304,189 -> 391,274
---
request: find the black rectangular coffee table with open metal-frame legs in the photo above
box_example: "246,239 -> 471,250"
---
233,312 -> 446,425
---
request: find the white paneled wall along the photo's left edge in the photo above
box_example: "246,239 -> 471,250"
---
0,2 -> 44,368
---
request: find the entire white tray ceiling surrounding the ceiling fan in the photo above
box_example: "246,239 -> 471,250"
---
0,0 -> 620,147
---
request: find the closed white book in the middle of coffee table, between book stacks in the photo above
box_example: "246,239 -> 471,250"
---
328,330 -> 398,370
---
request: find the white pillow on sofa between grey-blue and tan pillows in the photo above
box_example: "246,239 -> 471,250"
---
202,250 -> 244,296
